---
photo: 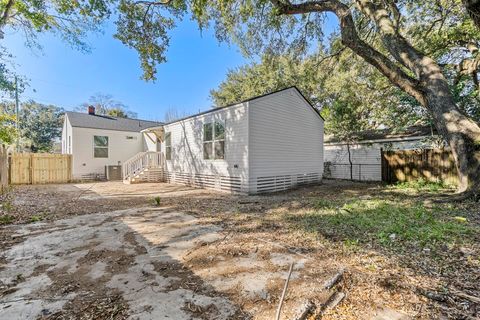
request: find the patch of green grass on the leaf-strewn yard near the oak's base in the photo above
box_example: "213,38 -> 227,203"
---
289,199 -> 480,248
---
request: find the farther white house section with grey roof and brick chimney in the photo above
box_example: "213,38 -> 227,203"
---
61,107 -> 161,179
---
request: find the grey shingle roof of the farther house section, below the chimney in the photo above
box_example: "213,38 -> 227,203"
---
65,111 -> 162,132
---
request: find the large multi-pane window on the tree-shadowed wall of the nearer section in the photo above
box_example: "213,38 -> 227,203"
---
203,121 -> 225,160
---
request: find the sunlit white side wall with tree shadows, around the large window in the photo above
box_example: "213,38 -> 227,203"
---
161,104 -> 248,192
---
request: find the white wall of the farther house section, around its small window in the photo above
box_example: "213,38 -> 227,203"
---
72,127 -> 145,179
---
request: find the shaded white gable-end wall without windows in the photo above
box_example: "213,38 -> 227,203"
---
249,88 -> 323,193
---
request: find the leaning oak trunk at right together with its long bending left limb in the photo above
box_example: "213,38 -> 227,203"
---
271,0 -> 480,196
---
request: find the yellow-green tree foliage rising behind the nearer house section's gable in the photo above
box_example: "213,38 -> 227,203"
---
211,50 -> 430,134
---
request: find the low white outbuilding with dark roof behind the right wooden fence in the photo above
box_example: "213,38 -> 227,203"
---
324,126 -> 442,181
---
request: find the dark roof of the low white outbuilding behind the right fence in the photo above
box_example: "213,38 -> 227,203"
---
324,126 -> 437,143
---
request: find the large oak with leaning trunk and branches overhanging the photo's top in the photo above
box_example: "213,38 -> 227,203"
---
0,0 -> 480,195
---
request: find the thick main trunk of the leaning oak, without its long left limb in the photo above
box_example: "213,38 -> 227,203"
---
355,0 -> 480,196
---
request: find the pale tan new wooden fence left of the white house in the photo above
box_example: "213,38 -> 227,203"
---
10,153 -> 72,184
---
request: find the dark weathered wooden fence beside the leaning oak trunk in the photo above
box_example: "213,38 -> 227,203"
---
382,149 -> 458,185
